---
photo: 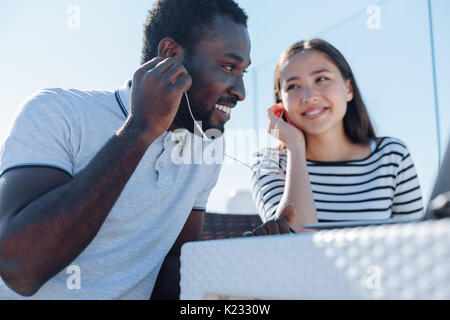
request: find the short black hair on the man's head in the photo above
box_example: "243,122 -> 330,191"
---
141,0 -> 248,64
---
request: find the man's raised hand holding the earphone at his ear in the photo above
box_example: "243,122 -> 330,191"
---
131,57 -> 192,136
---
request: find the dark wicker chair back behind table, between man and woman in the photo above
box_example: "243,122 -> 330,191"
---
200,212 -> 262,240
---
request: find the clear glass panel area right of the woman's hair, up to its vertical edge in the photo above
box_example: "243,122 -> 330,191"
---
319,0 -> 439,204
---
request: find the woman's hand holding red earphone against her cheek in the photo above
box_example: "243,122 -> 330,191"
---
267,104 -> 305,146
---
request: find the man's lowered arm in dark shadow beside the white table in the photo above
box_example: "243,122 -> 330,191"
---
151,210 -> 205,300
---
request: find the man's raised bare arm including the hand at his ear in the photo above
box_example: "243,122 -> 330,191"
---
0,58 -> 191,296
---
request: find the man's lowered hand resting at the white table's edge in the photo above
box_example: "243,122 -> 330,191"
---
243,204 -> 295,237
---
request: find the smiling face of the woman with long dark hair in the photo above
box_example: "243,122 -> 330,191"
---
280,50 -> 353,136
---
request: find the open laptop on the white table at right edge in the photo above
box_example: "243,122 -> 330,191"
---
303,141 -> 450,230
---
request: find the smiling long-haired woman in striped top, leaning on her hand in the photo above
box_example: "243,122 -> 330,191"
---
252,39 -> 424,231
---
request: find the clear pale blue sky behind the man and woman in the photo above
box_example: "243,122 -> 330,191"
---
0,0 -> 450,211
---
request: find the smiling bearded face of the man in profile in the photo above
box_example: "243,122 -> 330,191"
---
174,16 -> 250,132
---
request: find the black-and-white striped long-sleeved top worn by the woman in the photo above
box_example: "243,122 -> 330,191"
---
251,137 -> 424,222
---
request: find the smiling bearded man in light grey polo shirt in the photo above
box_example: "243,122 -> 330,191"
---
0,0 -> 250,299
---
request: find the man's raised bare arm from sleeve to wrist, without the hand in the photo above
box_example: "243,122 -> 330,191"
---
0,122 -> 157,296
